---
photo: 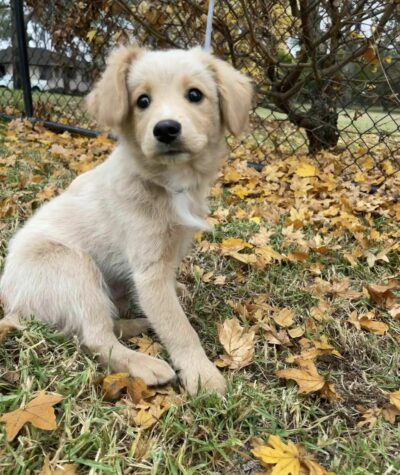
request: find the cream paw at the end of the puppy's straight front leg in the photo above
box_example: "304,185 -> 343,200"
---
180,359 -> 226,396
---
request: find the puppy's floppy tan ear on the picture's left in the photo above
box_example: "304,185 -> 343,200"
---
86,46 -> 141,128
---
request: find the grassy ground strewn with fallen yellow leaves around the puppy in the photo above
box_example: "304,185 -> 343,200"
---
0,122 -> 400,475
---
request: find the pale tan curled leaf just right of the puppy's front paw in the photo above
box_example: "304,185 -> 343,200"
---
215,318 -> 255,369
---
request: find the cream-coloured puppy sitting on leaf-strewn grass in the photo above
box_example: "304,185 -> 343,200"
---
1,47 -> 252,394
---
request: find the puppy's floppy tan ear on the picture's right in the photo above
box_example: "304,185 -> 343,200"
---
211,57 -> 254,135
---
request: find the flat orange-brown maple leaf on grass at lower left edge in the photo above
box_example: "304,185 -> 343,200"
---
0,391 -> 64,442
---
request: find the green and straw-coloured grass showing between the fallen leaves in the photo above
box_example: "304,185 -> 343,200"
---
0,121 -> 400,475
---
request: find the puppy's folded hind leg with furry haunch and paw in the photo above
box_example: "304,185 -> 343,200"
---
1,241 -> 175,385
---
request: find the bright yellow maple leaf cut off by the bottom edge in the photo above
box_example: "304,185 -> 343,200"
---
252,435 -> 335,475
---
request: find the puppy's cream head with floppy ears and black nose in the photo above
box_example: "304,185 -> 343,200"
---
88,47 -> 253,163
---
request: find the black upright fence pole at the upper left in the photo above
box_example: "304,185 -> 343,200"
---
12,0 -> 33,117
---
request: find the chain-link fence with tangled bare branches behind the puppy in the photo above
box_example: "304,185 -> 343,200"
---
0,0 -> 400,178
